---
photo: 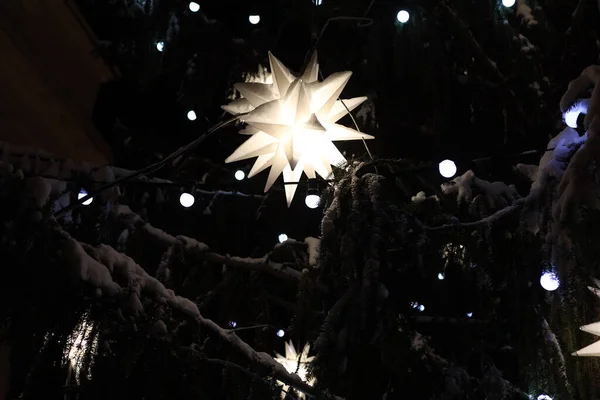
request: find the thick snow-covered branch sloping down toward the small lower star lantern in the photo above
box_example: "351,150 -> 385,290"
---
61,231 -> 342,400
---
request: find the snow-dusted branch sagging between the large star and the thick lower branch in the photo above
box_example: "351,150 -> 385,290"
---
115,205 -> 308,282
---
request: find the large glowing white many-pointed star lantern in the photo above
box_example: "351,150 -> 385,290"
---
223,53 -> 373,206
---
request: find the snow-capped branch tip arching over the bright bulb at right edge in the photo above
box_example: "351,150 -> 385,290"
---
560,65 -> 600,127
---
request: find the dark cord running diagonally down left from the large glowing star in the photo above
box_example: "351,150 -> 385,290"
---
54,116 -> 239,217
